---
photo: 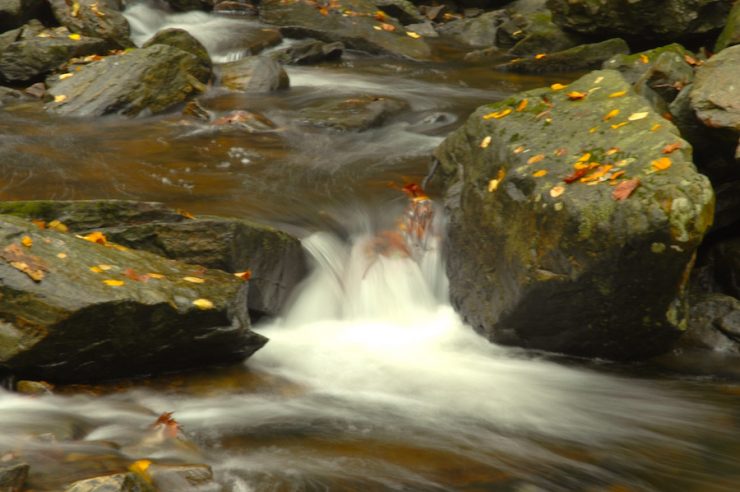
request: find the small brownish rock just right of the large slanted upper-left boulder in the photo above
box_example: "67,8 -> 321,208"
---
218,56 -> 290,92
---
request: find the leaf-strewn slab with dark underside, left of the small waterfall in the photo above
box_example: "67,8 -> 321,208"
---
0,216 -> 266,382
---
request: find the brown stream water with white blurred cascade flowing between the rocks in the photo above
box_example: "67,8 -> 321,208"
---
0,4 -> 740,492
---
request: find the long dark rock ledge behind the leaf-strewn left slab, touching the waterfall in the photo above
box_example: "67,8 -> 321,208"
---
0,200 -> 308,318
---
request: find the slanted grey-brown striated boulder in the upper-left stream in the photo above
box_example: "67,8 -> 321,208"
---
47,44 -> 211,116
